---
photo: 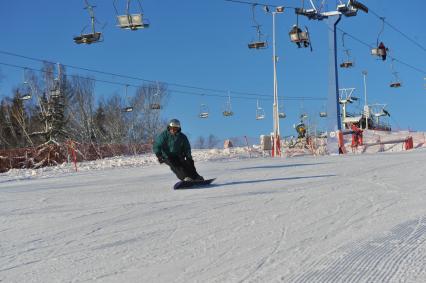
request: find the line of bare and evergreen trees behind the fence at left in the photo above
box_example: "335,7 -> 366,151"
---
0,63 -> 169,149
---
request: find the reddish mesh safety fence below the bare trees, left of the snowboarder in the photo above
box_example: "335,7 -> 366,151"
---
0,141 -> 152,173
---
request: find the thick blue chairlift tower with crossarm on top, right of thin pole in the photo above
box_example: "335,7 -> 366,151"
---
295,0 -> 368,154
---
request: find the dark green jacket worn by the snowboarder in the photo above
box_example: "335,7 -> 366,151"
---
153,130 -> 192,159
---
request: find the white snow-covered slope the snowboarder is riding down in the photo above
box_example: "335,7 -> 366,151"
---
0,132 -> 426,282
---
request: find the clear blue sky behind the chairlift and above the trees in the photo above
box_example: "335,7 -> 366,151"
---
0,0 -> 426,142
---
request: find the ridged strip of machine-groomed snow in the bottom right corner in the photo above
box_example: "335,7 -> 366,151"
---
290,217 -> 426,282
